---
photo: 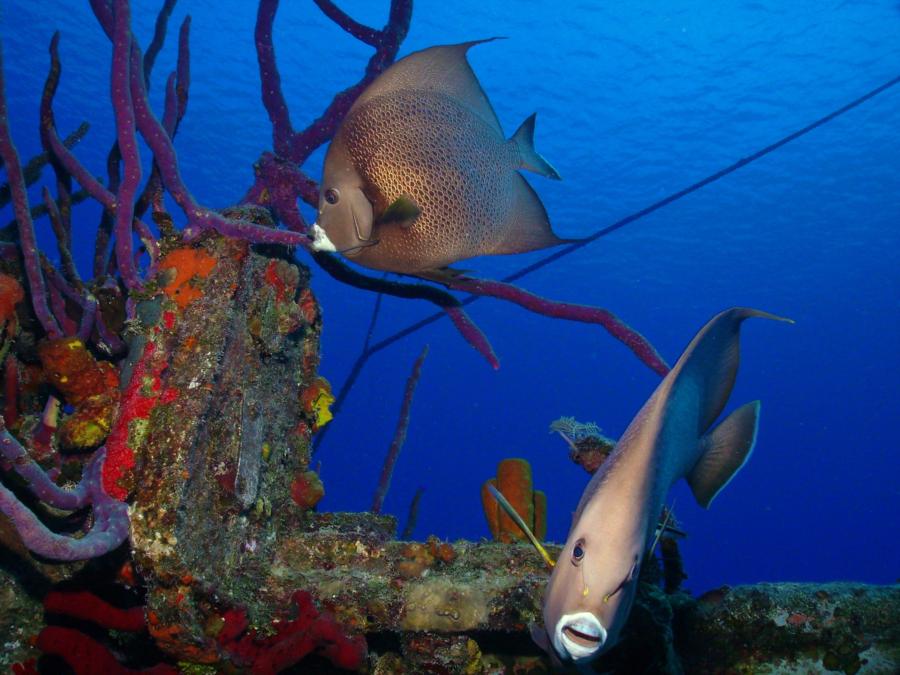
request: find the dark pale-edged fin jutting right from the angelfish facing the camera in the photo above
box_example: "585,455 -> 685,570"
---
687,401 -> 760,508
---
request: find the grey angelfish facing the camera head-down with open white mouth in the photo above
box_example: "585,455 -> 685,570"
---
532,307 -> 792,666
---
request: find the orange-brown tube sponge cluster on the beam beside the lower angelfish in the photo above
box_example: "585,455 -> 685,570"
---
481,457 -> 547,544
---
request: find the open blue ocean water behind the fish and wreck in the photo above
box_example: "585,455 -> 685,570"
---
0,0 -> 900,591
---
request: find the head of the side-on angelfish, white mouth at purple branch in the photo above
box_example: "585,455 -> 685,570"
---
312,158 -> 378,258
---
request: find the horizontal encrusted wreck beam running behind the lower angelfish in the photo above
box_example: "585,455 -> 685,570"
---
139,504 -> 900,674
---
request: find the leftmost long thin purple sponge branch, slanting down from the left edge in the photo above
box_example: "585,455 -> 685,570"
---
0,44 -> 62,338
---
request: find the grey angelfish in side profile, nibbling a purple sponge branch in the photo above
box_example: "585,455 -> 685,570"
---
312,40 -> 571,276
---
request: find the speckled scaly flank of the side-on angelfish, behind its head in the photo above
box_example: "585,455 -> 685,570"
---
335,91 -> 518,273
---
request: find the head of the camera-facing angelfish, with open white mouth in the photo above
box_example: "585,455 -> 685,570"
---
533,524 -> 642,665
